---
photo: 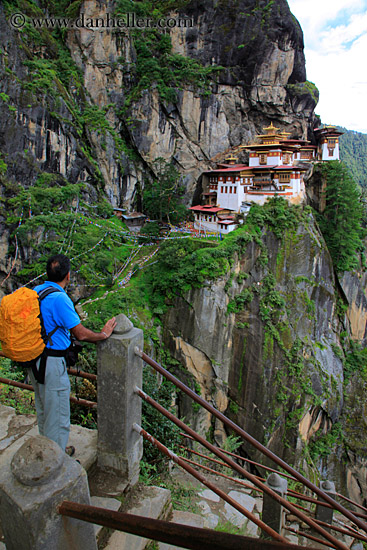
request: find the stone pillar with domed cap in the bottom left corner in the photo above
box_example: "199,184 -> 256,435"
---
0,435 -> 97,550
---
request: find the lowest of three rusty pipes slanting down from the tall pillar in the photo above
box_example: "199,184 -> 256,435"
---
133,424 -> 287,543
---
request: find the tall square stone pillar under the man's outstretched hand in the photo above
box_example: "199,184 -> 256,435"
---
97,314 -> 144,485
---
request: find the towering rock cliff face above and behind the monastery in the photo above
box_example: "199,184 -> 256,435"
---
0,0 -> 315,282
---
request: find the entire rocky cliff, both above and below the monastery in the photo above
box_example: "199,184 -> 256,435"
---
0,0 -> 367,508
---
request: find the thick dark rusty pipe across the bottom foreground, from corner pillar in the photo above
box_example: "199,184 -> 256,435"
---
59,501 -> 320,550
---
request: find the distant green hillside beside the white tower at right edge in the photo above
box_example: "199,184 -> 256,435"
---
338,126 -> 367,187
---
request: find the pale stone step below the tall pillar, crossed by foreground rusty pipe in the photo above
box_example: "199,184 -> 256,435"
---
104,486 -> 171,550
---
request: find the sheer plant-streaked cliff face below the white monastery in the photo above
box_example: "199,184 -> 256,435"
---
164,217 -> 367,502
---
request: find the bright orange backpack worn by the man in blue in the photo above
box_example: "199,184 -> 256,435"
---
0,287 -> 59,366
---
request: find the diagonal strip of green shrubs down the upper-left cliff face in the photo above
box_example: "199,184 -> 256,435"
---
2,0 -> 135,188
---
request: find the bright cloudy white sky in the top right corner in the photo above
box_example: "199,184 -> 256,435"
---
288,0 -> 367,133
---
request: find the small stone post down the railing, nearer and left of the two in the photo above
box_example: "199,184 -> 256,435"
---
261,473 -> 288,538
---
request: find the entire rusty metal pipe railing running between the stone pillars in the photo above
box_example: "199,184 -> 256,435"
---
4,348 -> 367,550
